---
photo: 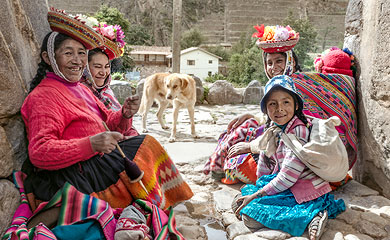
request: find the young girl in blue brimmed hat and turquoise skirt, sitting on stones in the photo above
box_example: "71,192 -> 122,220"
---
228,75 -> 345,239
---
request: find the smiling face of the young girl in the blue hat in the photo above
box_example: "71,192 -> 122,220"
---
266,89 -> 296,125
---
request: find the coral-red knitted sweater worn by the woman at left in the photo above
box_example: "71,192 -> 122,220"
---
21,77 -> 132,170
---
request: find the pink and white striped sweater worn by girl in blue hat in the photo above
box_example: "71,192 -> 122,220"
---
251,116 -> 331,203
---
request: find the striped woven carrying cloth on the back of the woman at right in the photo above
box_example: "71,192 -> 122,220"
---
292,73 -> 357,168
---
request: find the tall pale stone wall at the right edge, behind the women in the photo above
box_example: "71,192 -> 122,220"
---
344,0 -> 390,197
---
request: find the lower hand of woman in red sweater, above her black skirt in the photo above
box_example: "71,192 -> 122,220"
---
89,131 -> 123,153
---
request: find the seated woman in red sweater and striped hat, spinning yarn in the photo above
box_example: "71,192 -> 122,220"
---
21,9 -> 193,210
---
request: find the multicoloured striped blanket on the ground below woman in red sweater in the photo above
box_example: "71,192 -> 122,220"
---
2,171 -> 184,240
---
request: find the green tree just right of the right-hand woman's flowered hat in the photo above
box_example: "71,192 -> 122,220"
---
283,11 -> 317,70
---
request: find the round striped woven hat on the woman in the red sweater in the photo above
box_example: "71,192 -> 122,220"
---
47,8 -> 104,49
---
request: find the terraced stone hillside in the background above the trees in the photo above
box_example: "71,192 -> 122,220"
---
49,0 -> 348,51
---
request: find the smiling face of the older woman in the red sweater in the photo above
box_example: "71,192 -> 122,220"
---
55,39 -> 88,82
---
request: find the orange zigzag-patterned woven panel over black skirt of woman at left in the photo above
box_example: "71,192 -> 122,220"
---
124,135 -> 194,209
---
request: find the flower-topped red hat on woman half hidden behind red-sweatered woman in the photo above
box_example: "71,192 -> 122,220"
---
94,23 -> 126,60
